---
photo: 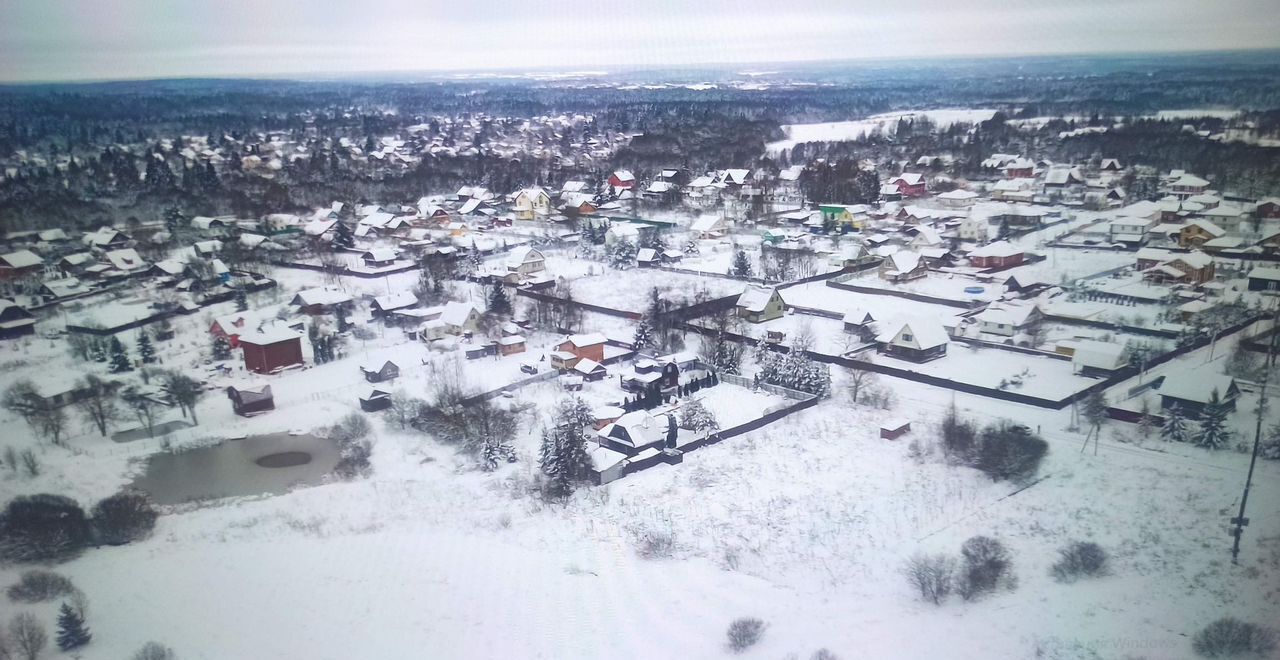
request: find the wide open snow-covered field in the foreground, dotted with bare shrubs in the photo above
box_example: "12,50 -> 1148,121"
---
0,335 -> 1280,660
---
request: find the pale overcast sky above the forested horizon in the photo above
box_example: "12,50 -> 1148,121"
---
0,0 -> 1280,82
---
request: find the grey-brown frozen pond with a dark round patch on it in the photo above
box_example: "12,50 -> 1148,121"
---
133,434 -> 339,504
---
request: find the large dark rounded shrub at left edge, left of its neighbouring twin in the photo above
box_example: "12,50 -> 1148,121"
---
0,495 -> 90,562
